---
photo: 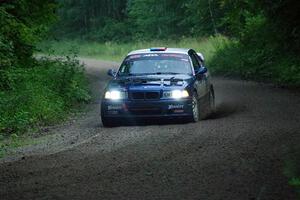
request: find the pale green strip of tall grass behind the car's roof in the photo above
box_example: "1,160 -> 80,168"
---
38,35 -> 227,62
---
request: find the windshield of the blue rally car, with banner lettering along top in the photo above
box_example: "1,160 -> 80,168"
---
118,53 -> 192,76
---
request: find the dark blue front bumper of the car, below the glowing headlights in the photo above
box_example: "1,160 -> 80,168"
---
101,98 -> 192,118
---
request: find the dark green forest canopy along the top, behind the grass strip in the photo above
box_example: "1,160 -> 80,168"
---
49,0 -> 300,51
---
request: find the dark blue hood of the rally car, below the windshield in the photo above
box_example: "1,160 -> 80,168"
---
108,74 -> 193,90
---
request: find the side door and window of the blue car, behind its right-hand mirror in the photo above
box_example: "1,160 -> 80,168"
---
189,51 -> 207,98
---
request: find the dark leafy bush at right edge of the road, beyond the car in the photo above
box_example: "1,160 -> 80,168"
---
210,14 -> 300,86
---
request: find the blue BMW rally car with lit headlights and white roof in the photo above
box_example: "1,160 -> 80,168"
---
101,47 -> 215,127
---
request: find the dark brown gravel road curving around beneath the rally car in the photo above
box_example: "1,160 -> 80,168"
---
0,59 -> 300,200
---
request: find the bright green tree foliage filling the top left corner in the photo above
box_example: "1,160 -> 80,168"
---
0,0 -> 56,69
